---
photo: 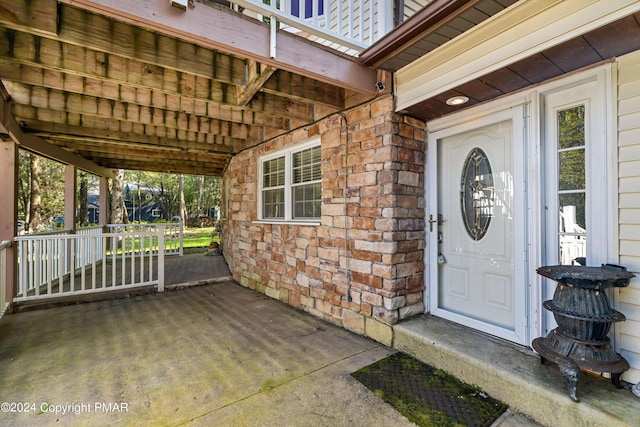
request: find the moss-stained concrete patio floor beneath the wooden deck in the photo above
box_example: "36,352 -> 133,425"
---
0,254 -> 536,427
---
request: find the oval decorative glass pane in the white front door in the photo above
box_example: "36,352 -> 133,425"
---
460,148 -> 494,240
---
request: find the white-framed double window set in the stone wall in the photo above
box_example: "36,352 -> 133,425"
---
260,140 -> 322,221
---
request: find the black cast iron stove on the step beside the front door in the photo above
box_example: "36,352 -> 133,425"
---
532,264 -> 635,402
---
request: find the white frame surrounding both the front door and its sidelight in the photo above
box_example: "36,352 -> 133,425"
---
424,63 -> 617,345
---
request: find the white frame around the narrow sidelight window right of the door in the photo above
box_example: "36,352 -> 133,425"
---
539,64 -> 618,335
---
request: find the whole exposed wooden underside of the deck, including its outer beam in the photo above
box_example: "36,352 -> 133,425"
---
0,0 -> 375,175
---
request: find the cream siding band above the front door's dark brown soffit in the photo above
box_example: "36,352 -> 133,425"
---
395,0 -> 640,110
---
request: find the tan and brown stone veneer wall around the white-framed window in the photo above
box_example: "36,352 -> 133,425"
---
223,97 -> 425,345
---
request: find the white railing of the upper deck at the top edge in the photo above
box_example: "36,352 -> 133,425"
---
233,0 -> 394,56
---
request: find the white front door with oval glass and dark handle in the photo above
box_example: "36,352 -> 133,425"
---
427,107 -> 527,344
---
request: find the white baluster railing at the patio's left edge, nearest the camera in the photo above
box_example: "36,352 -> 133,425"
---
14,224 -> 174,302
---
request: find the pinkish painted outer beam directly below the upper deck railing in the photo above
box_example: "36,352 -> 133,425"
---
56,0 -> 377,97
